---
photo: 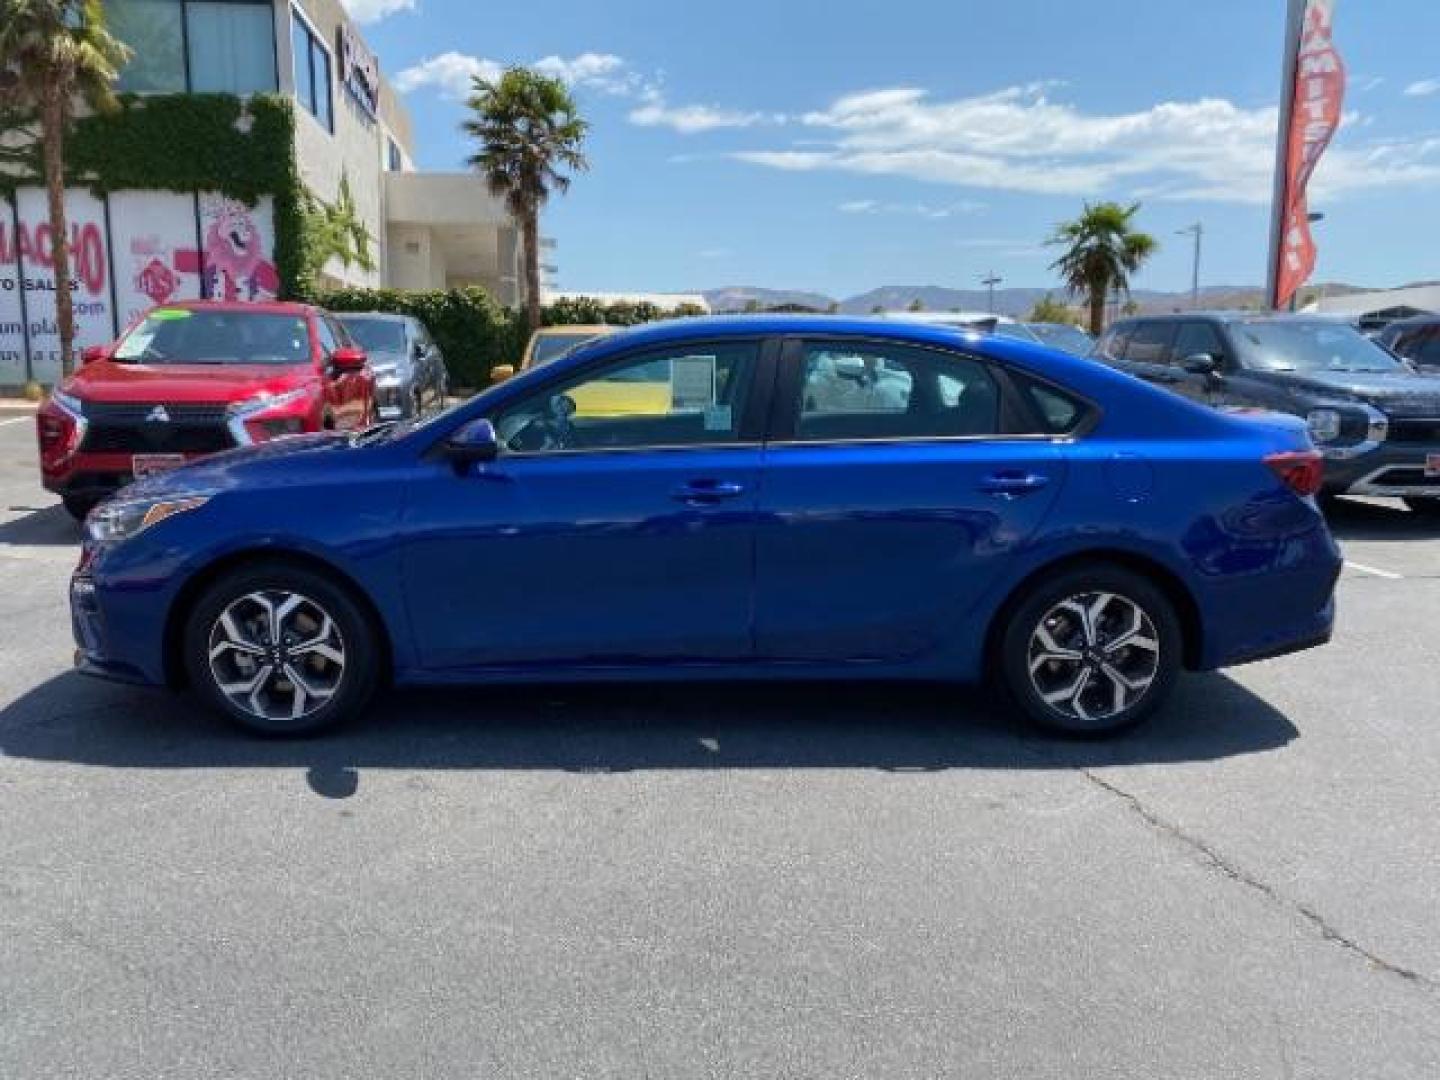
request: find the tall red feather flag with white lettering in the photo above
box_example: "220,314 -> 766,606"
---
1270,0 -> 1345,308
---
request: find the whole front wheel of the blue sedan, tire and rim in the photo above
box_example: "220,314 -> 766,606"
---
184,563 -> 379,734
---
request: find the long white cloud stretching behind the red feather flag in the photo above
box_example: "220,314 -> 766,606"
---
733,84 -> 1440,203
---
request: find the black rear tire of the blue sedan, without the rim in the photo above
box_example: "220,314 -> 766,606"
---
994,563 -> 1184,736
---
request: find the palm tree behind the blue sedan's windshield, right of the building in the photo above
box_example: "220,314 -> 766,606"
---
461,68 -> 590,330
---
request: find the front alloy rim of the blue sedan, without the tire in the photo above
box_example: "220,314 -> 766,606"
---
209,589 -> 346,721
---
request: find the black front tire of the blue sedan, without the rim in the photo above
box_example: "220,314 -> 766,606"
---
181,562 -> 382,736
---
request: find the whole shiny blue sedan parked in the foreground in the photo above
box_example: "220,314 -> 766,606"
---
71,317 -> 1341,733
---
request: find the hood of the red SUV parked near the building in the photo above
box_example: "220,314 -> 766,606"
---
63,360 -> 320,405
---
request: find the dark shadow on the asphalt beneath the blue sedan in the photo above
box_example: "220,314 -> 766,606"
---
0,674 -> 1299,798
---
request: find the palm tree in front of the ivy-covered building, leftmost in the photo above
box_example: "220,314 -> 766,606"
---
0,0 -> 130,376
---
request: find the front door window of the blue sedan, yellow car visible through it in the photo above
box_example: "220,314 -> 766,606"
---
495,341 -> 759,454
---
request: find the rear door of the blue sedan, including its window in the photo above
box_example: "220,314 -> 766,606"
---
755,338 -> 1066,661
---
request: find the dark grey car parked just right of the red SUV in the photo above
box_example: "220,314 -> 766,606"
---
337,311 -> 449,420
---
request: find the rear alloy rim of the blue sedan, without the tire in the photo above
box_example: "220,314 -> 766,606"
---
1027,592 -> 1161,723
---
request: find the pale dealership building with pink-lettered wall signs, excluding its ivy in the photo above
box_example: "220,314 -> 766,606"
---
0,0 -> 523,387
